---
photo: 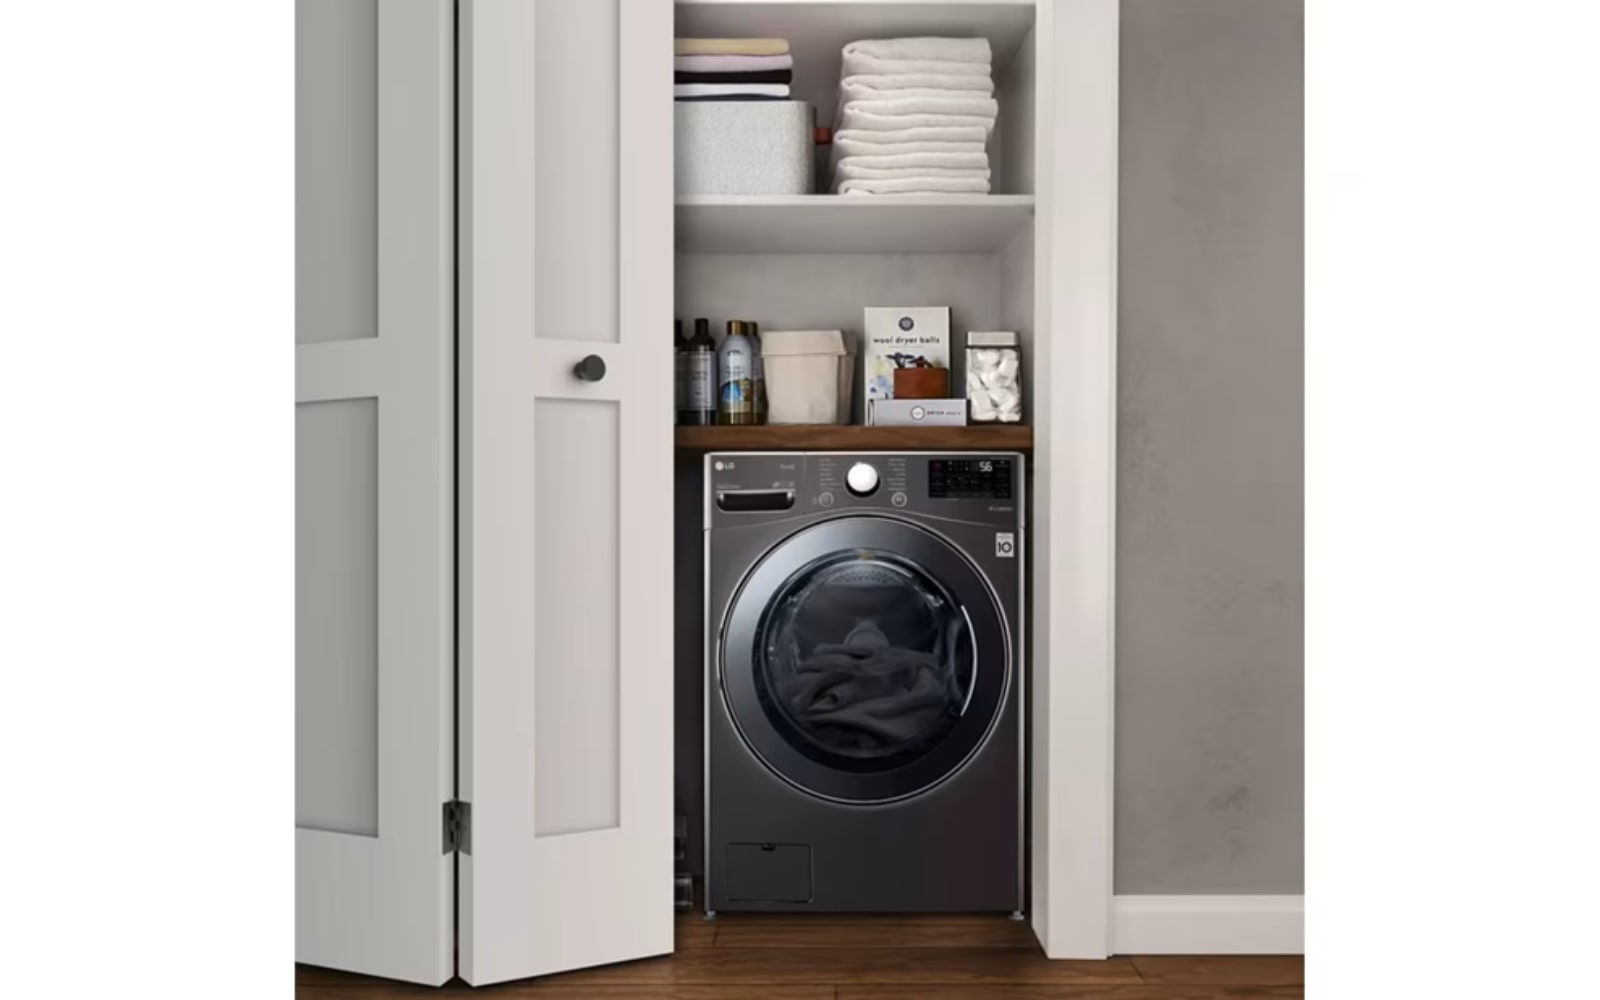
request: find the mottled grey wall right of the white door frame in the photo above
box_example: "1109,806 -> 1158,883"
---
1115,0 -> 1304,894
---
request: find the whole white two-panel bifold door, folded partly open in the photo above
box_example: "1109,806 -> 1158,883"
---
296,0 -> 674,984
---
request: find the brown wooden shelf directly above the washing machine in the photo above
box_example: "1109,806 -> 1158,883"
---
677,424 -> 1034,453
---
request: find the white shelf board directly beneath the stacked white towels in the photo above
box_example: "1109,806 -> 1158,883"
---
677,195 -> 1034,253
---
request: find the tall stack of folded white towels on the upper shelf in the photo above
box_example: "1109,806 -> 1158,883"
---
834,38 -> 1000,195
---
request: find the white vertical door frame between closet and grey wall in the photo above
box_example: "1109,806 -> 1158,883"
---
1030,0 -> 1122,958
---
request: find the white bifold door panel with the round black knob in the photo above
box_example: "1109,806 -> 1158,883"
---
461,0 -> 674,984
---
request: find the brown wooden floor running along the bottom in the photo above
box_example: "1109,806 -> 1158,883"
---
294,914 -> 1306,1000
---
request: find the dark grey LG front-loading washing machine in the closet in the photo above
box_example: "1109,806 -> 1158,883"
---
704,453 -> 1024,914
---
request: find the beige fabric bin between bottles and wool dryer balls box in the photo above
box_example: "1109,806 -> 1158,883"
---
762,330 -> 856,424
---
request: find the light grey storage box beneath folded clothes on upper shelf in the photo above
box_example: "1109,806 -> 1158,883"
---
672,101 -> 814,195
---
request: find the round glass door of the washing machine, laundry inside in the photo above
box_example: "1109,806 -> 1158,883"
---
720,517 -> 1011,802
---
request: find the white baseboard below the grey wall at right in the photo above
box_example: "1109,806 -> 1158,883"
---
1110,896 -> 1306,955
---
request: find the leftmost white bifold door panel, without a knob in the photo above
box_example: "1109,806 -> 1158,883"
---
294,0 -> 454,984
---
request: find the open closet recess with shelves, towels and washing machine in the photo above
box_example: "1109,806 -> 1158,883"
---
674,0 -> 1040,914
